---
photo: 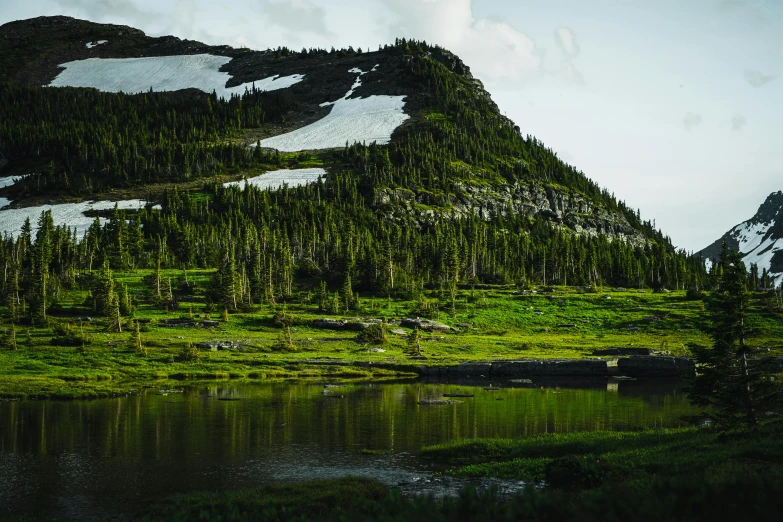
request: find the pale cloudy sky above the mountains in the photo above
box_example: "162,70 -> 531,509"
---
0,0 -> 783,251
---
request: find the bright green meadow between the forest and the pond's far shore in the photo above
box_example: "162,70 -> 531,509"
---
0,270 -> 783,398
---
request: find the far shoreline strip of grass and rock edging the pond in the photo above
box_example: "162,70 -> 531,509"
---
0,355 -> 695,401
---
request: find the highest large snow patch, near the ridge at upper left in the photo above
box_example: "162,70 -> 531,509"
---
49,54 -> 304,98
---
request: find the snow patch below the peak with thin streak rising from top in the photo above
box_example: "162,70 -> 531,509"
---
261,65 -> 410,152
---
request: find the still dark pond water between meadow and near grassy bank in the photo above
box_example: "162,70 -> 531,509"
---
0,380 -> 694,518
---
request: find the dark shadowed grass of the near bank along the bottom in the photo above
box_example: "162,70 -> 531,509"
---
133,422 -> 783,522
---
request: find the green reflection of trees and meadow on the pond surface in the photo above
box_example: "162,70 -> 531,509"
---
0,381 -> 691,462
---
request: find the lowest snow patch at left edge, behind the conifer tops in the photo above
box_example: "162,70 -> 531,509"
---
0,199 -> 154,237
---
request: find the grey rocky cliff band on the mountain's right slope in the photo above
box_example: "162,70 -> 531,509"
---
374,183 -> 647,246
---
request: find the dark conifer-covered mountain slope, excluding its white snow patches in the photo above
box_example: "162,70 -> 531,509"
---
0,17 -> 706,315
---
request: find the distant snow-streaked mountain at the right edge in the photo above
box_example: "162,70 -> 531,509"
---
698,191 -> 783,284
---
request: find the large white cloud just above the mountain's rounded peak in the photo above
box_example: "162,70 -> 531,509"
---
382,0 -> 541,85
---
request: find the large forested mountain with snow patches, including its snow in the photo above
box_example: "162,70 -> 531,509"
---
0,17 -> 706,293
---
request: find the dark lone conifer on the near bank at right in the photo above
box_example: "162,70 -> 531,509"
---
689,245 -> 780,429
